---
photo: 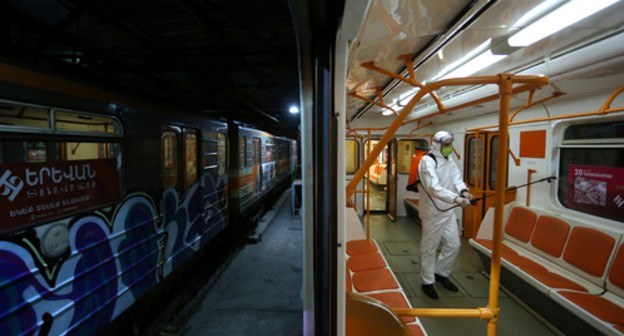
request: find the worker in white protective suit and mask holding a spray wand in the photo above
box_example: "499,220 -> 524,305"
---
418,131 -> 472,299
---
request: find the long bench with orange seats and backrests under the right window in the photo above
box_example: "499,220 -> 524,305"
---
470,204 -> 624,335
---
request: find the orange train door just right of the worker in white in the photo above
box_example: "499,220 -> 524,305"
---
463,132 -> 515,238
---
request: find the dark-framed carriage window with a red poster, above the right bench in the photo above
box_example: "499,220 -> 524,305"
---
557,121 -> 624,222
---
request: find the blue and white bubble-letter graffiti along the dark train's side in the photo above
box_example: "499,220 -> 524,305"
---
0,175 -> 227,335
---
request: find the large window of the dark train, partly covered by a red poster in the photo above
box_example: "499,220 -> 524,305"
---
0,136 -> 121,231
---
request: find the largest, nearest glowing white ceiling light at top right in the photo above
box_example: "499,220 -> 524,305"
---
508,0 -> 619,47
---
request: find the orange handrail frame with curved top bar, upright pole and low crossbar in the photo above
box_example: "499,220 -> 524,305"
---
346,63 -> 549,336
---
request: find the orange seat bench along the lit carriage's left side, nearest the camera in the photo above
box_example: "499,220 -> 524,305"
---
346,239 -> 426,336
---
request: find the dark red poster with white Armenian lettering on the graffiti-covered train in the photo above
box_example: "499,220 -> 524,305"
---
0,159 -> 119,230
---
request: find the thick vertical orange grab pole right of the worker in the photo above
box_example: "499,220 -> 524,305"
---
487,74 -> 513,336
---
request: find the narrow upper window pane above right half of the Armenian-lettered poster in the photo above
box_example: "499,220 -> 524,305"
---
54,111 -> 120,134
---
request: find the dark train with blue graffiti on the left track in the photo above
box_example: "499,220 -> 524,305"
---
0,64 -> 297,335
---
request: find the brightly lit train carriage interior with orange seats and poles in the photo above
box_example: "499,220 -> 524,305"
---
303,0 -> 624,335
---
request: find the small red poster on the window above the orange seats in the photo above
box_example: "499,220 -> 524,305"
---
568,164 -> 624,221
